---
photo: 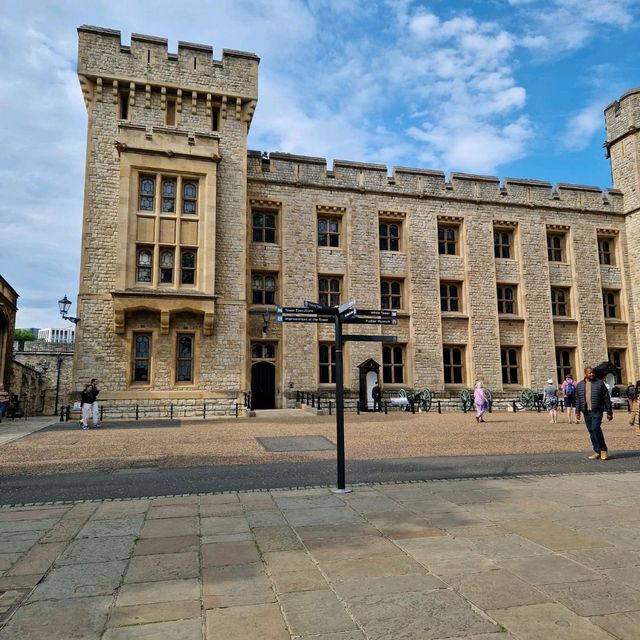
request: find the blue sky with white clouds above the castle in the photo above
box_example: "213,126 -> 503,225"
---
0,0 -> 640,327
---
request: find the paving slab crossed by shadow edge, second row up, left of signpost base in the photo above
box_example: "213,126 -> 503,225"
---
202,563 -> 275,609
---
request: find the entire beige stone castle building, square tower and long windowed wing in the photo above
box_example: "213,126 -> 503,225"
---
74,26 -> 640,407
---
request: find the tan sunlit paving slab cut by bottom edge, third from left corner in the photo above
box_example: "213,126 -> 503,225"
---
205,604 -> 291,640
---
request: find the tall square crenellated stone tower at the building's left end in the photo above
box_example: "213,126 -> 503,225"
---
75,26 -> 259,404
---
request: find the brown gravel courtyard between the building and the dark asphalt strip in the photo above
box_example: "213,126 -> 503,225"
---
0,411 -> 640,476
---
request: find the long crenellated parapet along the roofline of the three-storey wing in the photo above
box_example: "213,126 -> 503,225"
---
247,151 -> 623,214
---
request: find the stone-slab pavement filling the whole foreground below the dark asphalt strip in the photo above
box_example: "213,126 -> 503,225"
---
0,472 -> 640,640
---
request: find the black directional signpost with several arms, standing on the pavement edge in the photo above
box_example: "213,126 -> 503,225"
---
276,298 -> 398,493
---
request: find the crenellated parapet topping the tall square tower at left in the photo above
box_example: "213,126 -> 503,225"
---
78,25 -> 260,101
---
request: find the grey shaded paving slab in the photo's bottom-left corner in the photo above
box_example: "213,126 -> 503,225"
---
0,596 -> 112,640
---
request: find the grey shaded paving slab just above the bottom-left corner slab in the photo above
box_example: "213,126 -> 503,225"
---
29,561 -> 126,602
